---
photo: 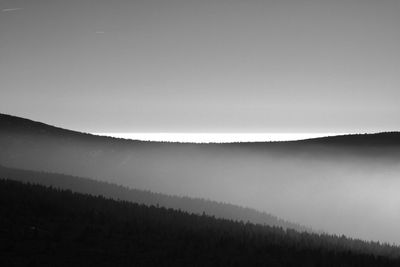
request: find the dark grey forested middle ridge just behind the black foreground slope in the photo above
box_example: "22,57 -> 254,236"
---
0,166 -> 312,232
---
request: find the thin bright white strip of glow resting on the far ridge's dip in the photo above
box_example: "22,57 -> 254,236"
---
93,133 -> 345,143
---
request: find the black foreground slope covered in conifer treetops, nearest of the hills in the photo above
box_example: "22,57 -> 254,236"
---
0,179 -> 400,267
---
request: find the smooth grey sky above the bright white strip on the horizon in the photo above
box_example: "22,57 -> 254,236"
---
0,0 -> 400,133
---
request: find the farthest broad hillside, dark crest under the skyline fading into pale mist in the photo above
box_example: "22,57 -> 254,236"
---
0,115 -> 400,247
